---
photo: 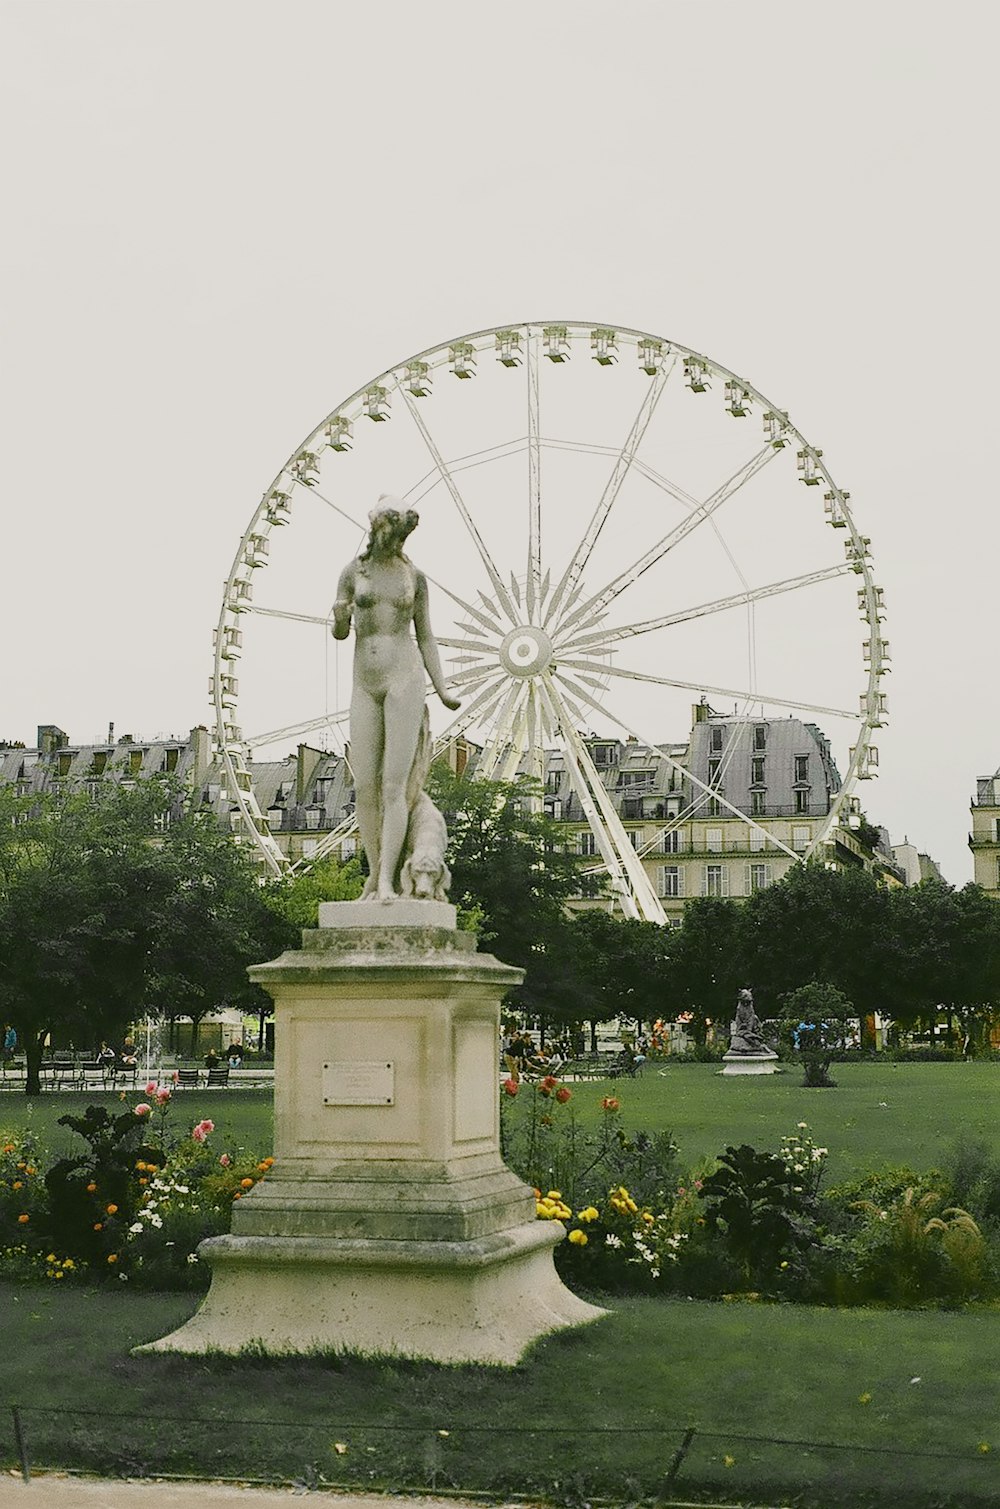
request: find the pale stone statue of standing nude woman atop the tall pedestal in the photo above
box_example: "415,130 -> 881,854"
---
332,495 -> 460,901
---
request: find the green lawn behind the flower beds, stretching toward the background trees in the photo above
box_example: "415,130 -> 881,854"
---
0,1062 -> 1000,1182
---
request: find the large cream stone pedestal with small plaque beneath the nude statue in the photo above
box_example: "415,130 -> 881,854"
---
140,901 -> 603,1363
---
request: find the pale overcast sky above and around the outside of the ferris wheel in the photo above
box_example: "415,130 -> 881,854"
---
0,0 -> 1000,884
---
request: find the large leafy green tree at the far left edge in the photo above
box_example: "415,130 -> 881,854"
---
0,780 -> 290,1094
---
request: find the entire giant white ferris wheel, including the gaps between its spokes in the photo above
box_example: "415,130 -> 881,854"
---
211,321 -> 888,922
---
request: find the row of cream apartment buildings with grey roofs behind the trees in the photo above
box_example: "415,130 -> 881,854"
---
0,702 -> 941,925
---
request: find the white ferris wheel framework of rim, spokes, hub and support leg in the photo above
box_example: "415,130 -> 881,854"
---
210,320 -> 890,924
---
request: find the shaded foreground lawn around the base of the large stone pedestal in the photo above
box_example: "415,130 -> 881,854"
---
0,1286 -> 1000,1509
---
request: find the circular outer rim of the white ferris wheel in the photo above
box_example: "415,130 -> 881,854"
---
213,320 -> 884,893
